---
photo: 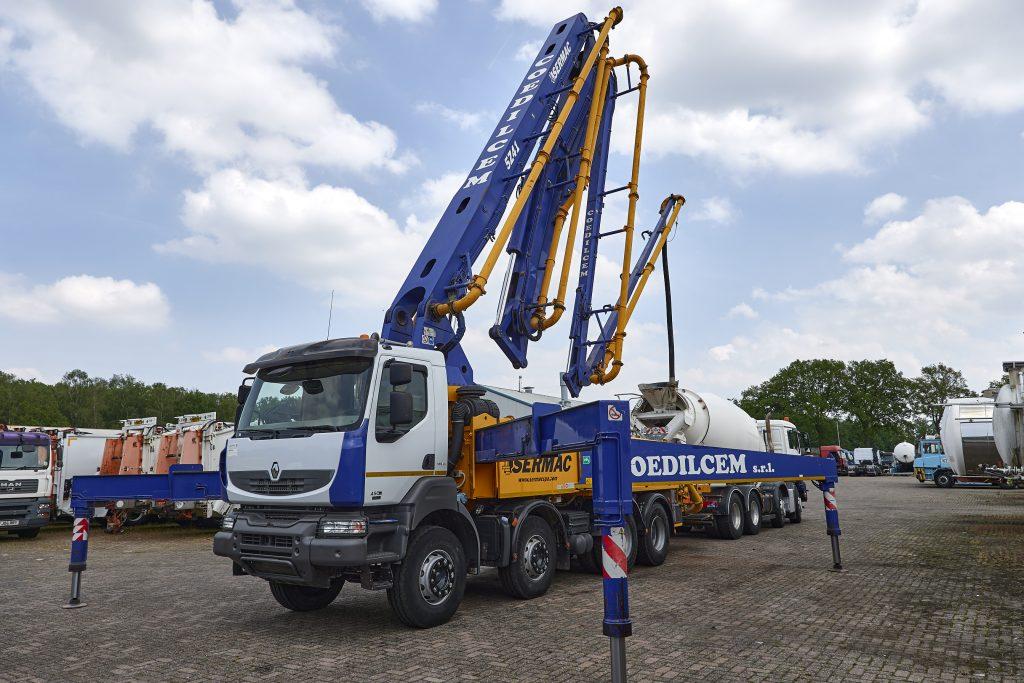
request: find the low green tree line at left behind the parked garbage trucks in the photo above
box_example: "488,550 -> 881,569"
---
0,370 -> 236,429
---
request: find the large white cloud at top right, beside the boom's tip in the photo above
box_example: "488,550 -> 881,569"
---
497,0 -> 1024,174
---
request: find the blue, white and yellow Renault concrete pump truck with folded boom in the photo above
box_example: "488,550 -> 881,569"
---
203,8 -> 839,635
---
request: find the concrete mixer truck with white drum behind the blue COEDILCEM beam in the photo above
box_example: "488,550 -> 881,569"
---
630,382 -> 807,539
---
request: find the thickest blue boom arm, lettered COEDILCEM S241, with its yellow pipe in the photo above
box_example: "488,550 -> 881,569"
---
382,10 -> 622,385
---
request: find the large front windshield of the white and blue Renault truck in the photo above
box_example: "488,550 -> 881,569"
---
239,357 -> 373,435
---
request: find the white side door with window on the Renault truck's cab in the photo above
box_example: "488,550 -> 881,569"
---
364,356 -> 438,505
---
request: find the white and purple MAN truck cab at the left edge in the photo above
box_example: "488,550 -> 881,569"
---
0,430 -> 53,539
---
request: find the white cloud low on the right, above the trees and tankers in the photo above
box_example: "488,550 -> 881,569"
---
689,197 -> 1024,394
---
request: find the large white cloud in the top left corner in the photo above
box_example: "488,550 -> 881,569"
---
0,0 -> 412,175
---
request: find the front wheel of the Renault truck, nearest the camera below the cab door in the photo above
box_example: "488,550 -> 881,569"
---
387,525 -> 466,629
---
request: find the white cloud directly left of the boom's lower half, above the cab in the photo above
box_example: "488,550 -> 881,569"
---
158,170 -> 426,307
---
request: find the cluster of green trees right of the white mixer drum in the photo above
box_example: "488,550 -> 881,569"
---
735,358 -> 1002,451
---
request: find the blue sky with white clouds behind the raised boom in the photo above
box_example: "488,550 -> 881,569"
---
0,0 -> 1024,398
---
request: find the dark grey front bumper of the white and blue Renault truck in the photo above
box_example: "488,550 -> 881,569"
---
213,509 -> 408,587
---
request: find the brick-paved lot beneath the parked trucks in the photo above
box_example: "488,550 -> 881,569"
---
0,477 -> 1024,682
